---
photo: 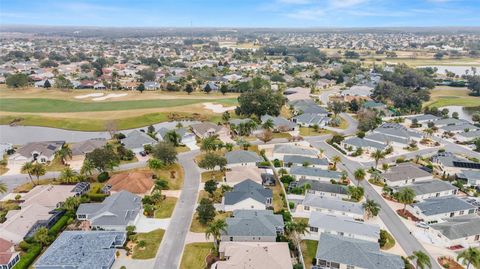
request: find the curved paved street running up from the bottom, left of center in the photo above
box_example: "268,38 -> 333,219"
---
153,150 -> 200,269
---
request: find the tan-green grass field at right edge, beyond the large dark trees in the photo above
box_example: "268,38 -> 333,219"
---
424,86 -> 480,107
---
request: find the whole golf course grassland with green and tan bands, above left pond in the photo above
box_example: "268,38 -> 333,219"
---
0,87 -> 238,131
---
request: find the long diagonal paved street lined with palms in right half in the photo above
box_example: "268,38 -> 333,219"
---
308,137 -> 441,269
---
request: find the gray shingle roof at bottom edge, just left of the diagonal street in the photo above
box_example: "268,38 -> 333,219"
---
315,233 -> 405,269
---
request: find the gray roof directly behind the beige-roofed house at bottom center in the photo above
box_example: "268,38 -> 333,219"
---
226,210 -> 284,236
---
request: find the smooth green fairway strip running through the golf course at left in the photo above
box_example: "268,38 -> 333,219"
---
0,98 -> 237,113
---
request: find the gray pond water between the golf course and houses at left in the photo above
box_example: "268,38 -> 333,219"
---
0,121 -> 194,145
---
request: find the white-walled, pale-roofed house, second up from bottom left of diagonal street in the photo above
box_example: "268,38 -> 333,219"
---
304,212 -> 380,242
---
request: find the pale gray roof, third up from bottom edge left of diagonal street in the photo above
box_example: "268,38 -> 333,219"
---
302,193 -> 364,215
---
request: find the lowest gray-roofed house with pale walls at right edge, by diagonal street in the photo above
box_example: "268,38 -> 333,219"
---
430,215 -> 480,247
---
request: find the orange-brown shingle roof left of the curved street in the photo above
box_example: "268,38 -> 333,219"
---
107,171 -> 153,194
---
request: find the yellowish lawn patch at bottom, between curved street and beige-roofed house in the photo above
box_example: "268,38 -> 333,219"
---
180,243 -> 213,269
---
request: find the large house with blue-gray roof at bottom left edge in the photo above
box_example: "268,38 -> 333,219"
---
34,231 -> 127,269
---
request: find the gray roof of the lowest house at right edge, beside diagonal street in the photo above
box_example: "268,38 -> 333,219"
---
430,215 -> 480,240
